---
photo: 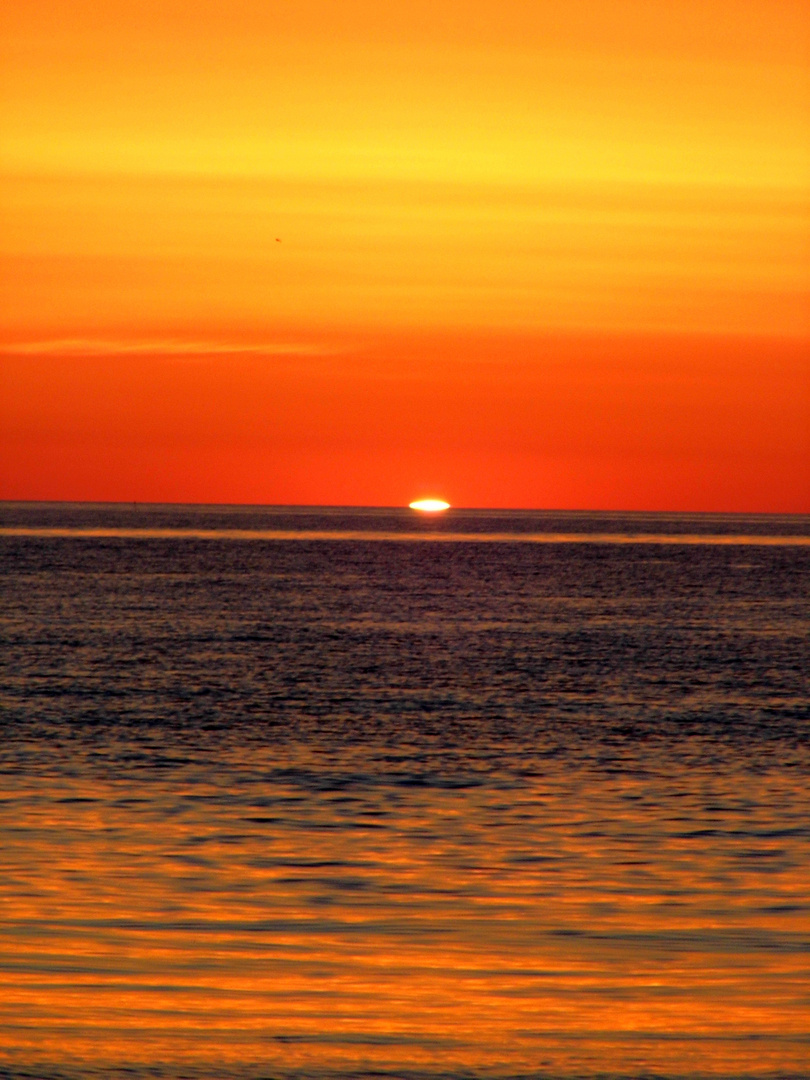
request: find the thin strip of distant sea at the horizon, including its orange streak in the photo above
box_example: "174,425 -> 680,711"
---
0,501 -> 810,544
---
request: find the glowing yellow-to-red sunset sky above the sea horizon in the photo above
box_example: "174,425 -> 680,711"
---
0,0 -> 810,512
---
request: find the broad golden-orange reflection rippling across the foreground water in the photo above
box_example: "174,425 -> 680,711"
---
0,747 -> 810,1075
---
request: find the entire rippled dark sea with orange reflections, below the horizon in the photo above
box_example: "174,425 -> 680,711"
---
0,503 -> 810,1080
